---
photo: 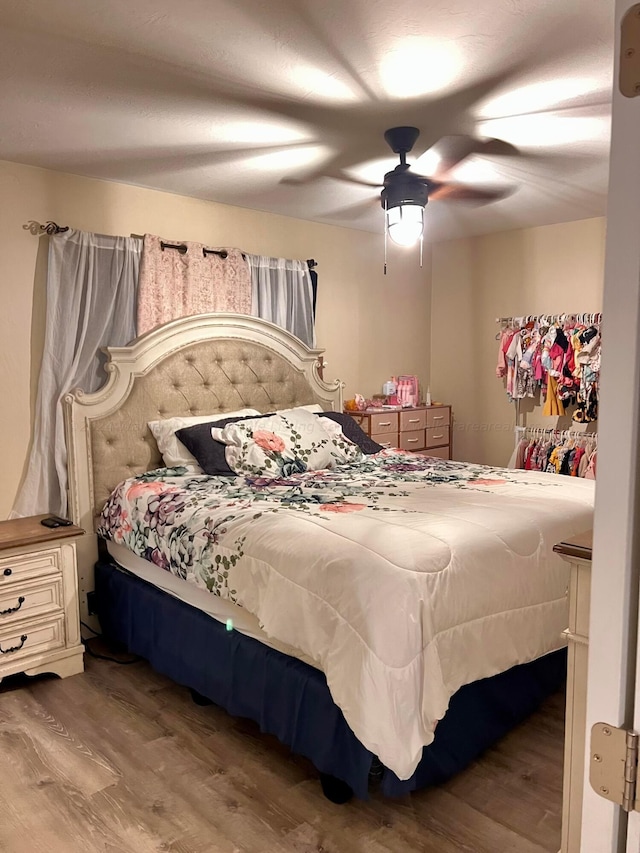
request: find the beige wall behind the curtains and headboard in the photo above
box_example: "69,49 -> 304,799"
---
0,162 -> 430,518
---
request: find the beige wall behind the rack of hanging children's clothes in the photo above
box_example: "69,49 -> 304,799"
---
430,218 -> 605,465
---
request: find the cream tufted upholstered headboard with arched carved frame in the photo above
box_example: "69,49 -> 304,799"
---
64,314 -> 343,620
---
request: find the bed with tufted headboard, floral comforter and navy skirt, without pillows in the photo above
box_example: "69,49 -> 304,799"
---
65,315 -> 593,799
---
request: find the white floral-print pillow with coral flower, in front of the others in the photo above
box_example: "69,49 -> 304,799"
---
211,408 -> 362,478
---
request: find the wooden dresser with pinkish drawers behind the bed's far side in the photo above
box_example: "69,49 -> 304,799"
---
347,406 -> 451,459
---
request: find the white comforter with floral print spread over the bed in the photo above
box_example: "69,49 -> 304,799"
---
98,451 -> 594,778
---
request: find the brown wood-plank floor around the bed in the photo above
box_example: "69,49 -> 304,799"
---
0,644 -> 564,853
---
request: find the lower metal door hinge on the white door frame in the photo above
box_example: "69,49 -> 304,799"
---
589,723 -> 640,812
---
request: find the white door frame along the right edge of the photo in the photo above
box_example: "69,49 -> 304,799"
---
581,0 -> 640,853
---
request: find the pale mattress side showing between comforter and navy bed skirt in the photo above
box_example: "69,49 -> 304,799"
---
106,540 -> 317,666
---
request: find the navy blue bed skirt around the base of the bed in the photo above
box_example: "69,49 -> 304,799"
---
96,561 -> 566,799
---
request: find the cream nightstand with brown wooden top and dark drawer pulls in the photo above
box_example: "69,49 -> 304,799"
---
0,515 -> 84,681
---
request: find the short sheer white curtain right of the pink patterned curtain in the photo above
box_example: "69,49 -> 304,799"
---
246,255 -> 316,347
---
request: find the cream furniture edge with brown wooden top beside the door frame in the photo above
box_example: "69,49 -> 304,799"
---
553,532 -> 592,853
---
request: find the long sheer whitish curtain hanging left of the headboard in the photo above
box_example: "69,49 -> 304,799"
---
11,230 -> 142,518
